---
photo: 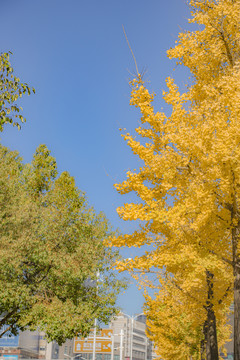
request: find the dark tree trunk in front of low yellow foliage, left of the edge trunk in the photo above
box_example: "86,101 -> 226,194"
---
204,270 -> 219,360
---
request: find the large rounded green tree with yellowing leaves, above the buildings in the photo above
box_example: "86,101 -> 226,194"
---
0,145 -> 122,344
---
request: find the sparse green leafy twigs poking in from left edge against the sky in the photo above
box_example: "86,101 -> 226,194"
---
0,52 -> 35,131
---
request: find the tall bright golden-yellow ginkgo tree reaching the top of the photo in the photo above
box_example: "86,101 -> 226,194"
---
111,0 -> 240,360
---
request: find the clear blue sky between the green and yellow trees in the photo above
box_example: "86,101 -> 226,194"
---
0,0 -> 190,314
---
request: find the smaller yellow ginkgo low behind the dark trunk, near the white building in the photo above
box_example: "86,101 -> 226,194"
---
145,270 -> 230,360
